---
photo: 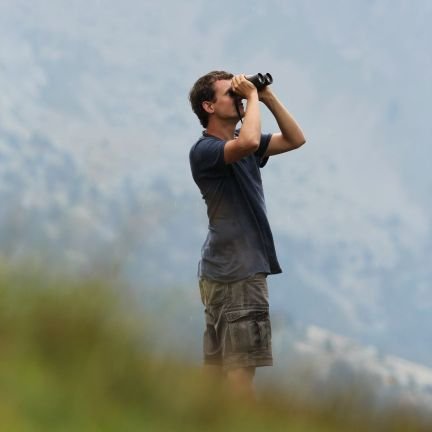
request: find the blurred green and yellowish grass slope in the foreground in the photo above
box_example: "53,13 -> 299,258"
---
0,264 -> 432,432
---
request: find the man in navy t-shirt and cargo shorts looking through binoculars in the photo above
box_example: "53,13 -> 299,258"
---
189,71 -> 305,395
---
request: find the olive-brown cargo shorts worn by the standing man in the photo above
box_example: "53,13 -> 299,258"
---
199,273 -> 273,369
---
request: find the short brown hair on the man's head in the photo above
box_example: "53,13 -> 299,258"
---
189,71 -> 234,127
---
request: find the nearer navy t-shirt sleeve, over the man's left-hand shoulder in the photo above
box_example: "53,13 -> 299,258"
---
191,138 -> 225,177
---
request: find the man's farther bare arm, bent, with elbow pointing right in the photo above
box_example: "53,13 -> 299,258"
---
259,87 -> 306,156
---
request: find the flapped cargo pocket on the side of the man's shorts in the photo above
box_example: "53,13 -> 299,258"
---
225,308 -> 271,352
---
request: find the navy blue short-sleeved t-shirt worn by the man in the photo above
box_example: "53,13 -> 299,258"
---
189,130 -> 282,282
